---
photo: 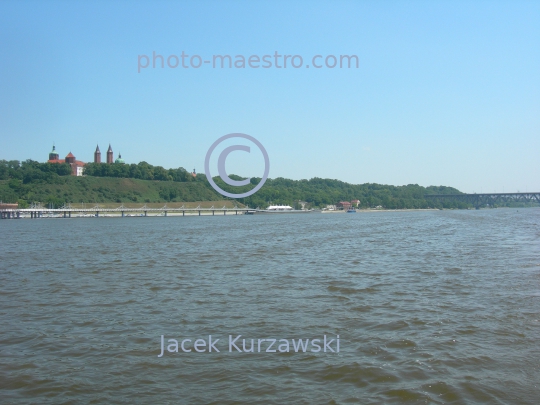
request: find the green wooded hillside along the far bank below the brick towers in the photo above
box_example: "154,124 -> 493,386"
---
0,160 -> 536,209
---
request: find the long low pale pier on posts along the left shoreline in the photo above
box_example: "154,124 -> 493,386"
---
0,204 -> 260,219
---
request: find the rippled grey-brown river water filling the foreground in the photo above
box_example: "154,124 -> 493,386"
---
0,208 -> 540,404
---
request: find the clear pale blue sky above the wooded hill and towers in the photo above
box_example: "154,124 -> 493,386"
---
0,0 -> 540,192
